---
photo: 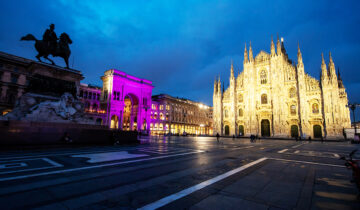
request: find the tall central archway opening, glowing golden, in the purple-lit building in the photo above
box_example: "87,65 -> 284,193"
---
122,93 -> 139,131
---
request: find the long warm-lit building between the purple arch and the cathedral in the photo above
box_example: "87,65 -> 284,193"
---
150,94 -> 212,135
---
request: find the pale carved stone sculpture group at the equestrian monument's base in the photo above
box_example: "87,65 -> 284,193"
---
0,93 -> 94,124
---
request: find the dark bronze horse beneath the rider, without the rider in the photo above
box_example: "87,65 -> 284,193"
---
20,33 -> 72,68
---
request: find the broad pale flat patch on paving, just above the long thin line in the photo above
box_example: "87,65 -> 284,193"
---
71,151 -> 149,163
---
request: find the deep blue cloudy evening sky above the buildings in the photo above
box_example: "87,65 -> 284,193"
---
0,0 -> 360,115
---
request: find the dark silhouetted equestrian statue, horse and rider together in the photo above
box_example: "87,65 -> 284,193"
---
20,24 -> 72,68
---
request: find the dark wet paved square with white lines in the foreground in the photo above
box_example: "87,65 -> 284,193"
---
0,137 -> 360,209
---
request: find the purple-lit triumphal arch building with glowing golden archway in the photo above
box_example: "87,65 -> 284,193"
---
100,69 -> 154,133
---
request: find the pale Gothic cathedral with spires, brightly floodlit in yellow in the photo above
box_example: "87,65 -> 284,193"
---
213,38 -> 350,138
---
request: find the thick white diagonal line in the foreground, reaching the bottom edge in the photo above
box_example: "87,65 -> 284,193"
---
139,157 -> 267,210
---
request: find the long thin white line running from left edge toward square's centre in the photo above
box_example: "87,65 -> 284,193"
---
0,150 -> 204,182
